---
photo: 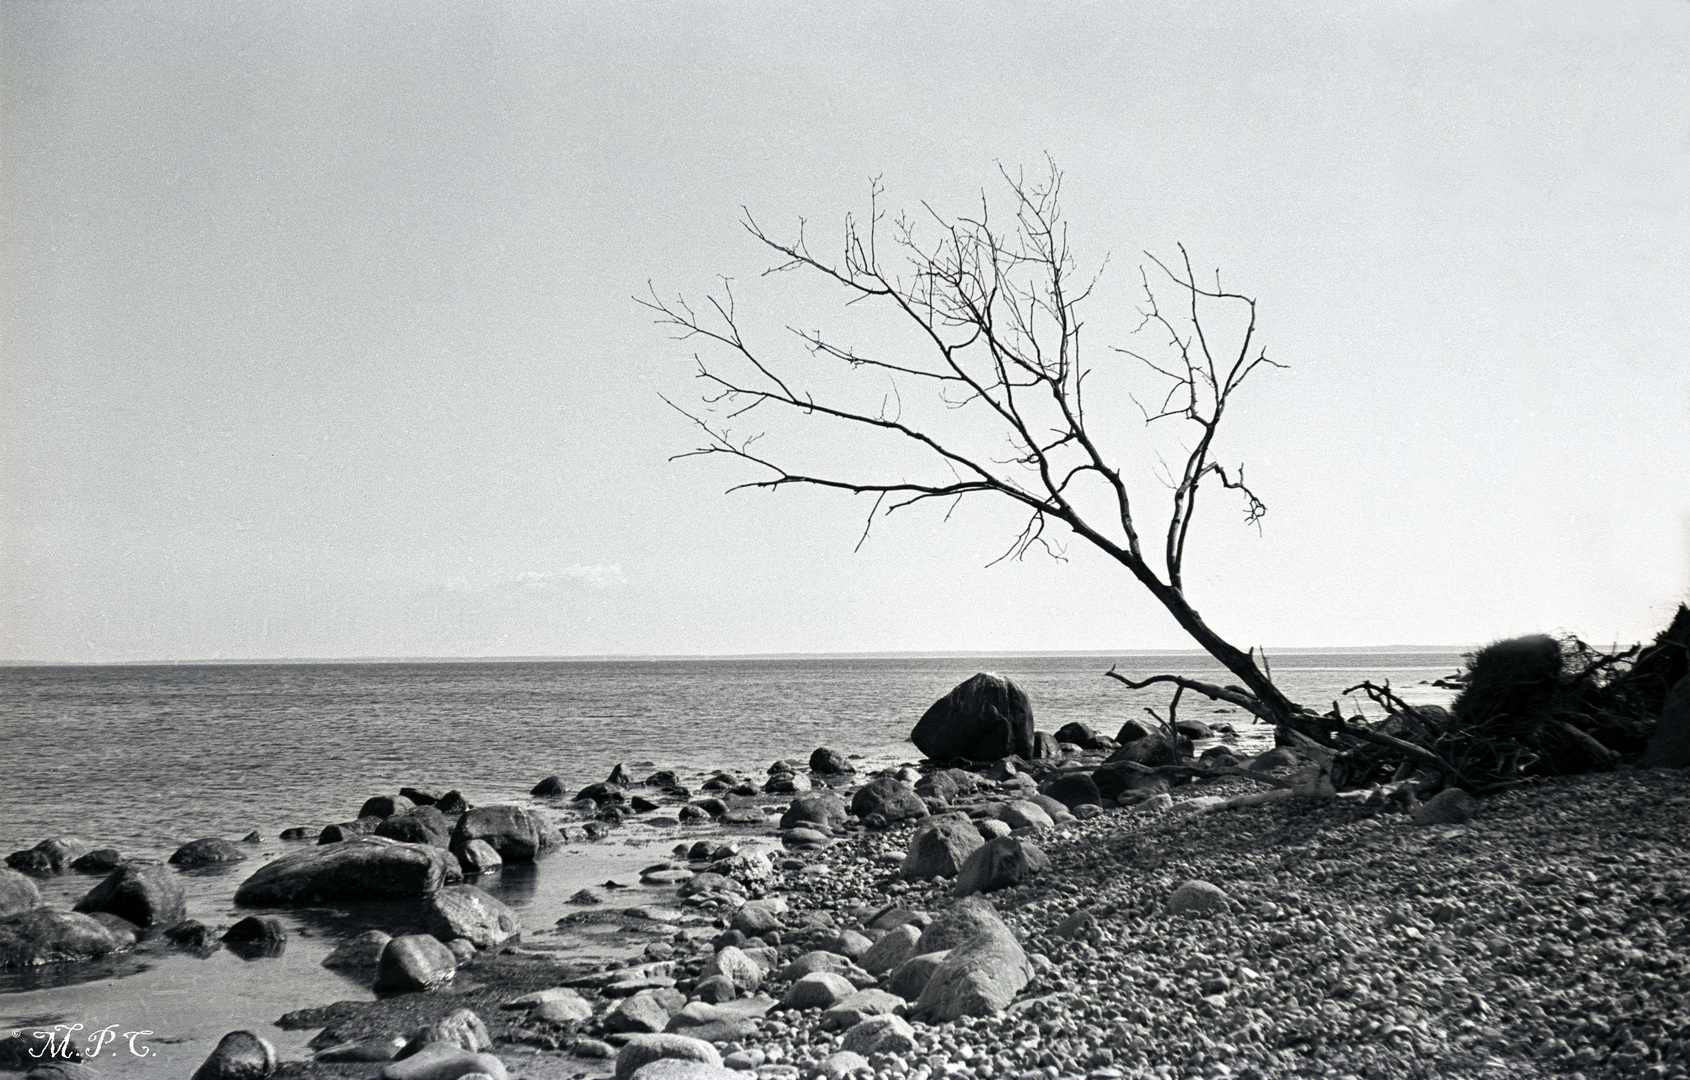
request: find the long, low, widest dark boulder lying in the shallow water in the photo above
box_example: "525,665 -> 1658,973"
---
235,837 -> 461,908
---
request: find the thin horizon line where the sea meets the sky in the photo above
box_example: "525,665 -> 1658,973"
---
0,644 -> 1480,668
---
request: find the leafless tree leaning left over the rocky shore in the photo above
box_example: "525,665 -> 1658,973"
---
641,166 -> 1330,735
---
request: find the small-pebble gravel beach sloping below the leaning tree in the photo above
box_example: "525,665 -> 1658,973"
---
267,760 -> 1690,1080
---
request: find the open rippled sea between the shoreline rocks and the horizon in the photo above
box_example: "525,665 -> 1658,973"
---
0,652 -> 1460,855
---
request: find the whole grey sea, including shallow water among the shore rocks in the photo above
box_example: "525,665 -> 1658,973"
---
0,649 -> 1462,1077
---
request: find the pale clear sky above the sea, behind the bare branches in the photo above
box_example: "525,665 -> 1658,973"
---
0,0 -> 1690,663
